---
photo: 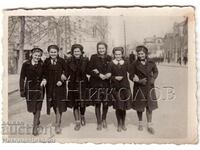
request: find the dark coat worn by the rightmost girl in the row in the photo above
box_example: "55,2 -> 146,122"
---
130,59 -> 158,111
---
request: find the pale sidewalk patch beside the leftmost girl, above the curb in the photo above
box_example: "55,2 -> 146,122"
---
8,74 -> 19,94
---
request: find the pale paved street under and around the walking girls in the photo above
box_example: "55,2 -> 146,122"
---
5,65 -> 187,141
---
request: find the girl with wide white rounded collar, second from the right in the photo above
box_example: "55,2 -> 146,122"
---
110,47 -> 132,132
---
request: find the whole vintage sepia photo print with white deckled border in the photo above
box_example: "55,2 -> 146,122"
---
2,6 -> 197,144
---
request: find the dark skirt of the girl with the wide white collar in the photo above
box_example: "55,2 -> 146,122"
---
113,89 -> 132,110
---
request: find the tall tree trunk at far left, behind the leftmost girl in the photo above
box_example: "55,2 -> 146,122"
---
17,16 -> 25,73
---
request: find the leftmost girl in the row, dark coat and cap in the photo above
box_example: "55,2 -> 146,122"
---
20,48 -> 44,135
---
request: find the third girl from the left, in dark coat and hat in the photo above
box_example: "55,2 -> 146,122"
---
67,44 -> 89,131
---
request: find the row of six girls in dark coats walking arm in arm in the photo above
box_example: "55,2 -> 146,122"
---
20,42 -> 158,135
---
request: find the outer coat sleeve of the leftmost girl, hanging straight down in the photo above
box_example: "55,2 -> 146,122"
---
19,63 -> 26,92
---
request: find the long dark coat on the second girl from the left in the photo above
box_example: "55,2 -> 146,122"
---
43,57 -> 67,114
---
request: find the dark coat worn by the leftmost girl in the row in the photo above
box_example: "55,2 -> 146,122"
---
19,60 -> 44,112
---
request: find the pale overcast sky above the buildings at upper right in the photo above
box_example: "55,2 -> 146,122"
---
109,16 -> 184,46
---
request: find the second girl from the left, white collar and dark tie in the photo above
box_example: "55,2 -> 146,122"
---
42,45 -> 67,134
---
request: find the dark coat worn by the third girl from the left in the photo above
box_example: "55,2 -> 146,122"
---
67,57 -> 89,107
